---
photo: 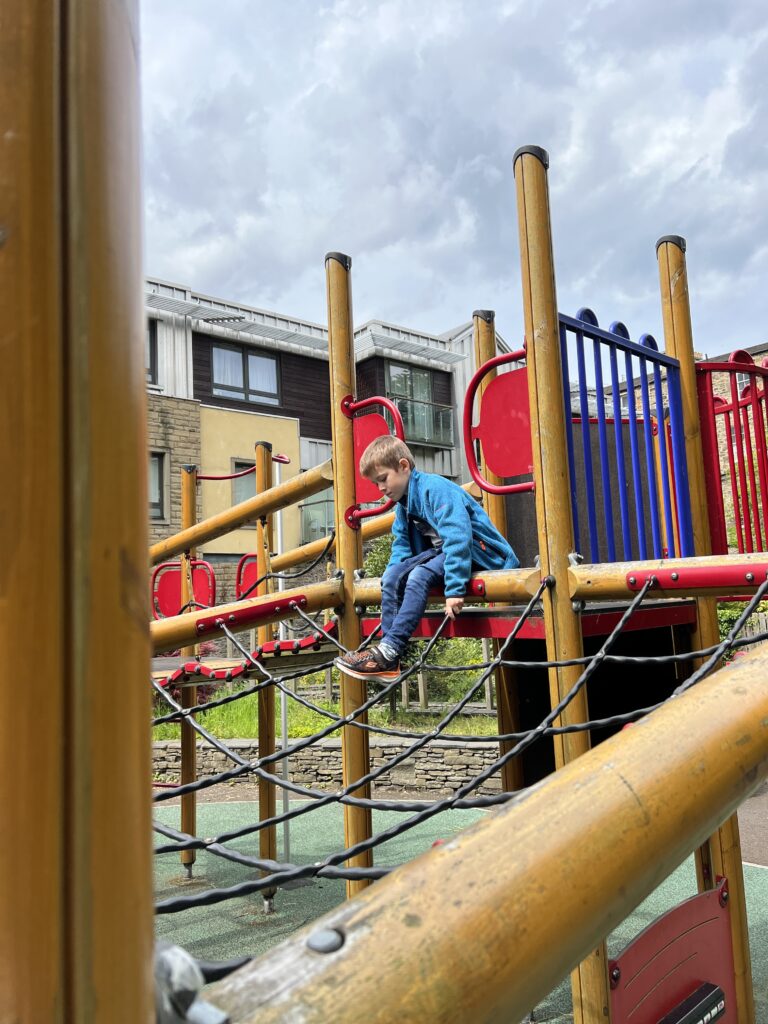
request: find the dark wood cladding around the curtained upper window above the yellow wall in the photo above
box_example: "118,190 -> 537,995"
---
193,333 -> 331,441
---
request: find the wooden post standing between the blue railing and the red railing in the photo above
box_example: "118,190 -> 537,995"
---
656,234 -> 755,1024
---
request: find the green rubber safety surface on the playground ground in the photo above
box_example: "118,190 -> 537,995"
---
155,802 -> 768,1024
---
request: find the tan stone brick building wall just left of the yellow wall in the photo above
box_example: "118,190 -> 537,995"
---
146,392 -> 201,544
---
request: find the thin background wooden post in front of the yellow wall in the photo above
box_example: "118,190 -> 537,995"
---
256,441 -> 278,913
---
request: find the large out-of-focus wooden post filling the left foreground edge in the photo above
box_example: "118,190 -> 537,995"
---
0,0 -> 155,1024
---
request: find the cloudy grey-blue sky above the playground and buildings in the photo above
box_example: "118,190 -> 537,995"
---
141,0 -> 768,354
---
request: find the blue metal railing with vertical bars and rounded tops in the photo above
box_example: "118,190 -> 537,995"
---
559,308 -> 693,563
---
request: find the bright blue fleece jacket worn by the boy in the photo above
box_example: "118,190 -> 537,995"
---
389,469 -> 520,597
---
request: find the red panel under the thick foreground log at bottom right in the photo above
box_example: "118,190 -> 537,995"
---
608,881 -> 736,1024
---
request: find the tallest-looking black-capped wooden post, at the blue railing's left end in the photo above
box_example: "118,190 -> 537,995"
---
514,146 -> 609,1024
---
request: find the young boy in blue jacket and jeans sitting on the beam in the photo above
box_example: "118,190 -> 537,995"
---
335,435 -> 520,682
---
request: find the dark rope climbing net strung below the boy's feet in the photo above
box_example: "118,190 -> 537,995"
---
152,577 -> 768,929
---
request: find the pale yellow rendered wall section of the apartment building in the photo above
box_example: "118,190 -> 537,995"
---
200,406 -> 301,554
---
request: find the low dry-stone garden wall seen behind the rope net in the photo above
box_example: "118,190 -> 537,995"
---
153,738 -> 501,798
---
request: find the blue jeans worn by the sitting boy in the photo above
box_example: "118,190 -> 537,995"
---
381,548 -> 445,655
